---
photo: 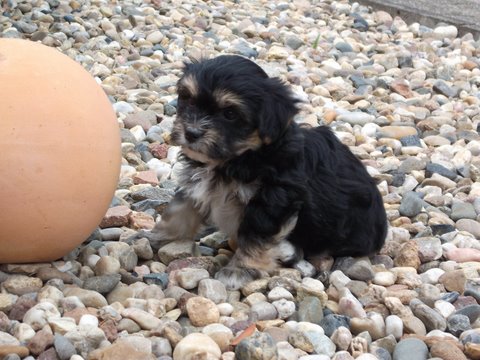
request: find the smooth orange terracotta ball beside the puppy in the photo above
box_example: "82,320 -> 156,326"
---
0,39 -> 121,263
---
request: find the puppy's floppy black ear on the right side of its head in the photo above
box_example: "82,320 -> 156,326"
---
258,78 -> 299,145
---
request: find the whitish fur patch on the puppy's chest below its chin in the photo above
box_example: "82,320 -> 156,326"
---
183,169 -> 258,235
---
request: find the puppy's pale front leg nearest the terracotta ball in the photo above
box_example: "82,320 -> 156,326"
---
127,191 -> 203,249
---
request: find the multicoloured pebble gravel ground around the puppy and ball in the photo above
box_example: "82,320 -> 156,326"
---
0,0 -> 480,360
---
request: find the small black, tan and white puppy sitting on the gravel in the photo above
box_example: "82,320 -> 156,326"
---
144,55 -> 387,289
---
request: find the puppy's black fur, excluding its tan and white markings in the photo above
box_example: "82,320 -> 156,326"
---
174,56 -> 387,256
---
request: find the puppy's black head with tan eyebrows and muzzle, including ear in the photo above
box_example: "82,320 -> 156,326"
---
172,55 -> 297,163
